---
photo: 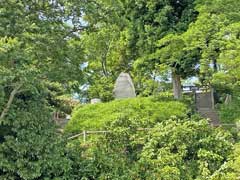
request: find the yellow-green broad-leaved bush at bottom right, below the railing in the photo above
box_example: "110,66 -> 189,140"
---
140,120 -> 232,179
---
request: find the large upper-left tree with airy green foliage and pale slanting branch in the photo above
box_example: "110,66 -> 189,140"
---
0,1 -> 86,120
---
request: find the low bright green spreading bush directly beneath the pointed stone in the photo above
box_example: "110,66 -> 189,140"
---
65,97 -> 188,132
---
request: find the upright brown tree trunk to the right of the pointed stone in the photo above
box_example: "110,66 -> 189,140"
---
172,72 -> 182,99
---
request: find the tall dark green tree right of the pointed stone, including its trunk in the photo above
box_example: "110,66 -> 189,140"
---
128,0 -> 197,98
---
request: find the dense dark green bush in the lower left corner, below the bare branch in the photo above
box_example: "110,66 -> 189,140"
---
0,87 -> 71,180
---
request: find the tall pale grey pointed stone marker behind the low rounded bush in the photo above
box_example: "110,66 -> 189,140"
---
113,72 -> 136,99
